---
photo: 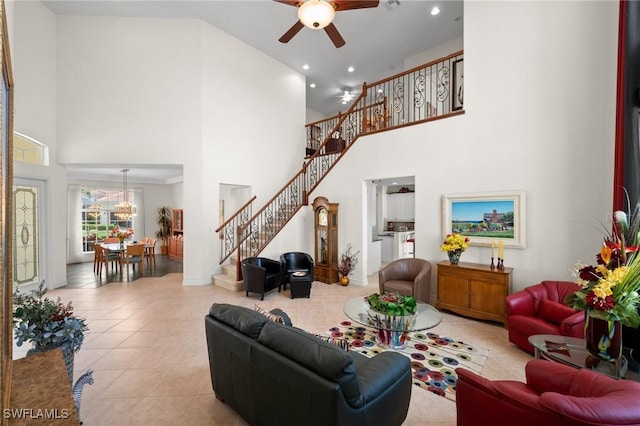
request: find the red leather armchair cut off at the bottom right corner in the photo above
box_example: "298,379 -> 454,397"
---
456,359 -> 640,426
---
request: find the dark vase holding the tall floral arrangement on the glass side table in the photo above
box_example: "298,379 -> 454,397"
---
584,314 -> 622,362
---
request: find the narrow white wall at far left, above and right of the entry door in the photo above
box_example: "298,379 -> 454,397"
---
7,1 -> 67,288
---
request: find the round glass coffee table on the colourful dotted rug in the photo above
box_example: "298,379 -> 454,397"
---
344,297 -> 442,349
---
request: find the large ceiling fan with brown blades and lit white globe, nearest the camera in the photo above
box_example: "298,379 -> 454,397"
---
274,0 -> 379,47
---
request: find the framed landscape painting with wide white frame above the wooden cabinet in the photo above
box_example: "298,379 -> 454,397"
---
442,191 -> 525,248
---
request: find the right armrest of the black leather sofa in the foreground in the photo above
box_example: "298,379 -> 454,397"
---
356,351 -> 413,407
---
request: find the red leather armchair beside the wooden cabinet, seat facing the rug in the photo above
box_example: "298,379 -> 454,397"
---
505,281 -> 584,353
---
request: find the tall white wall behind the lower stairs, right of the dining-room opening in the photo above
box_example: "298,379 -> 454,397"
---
198,20 -> 305,283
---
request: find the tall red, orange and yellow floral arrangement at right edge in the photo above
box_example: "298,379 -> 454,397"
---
564,209 -> 640,328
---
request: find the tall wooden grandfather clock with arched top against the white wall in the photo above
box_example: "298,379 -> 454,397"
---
312,197 -> 338,284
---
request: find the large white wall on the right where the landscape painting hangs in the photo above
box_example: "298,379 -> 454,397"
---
298,2 -> 618,294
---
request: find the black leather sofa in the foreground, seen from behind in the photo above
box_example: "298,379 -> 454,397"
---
205,304 -> 412,426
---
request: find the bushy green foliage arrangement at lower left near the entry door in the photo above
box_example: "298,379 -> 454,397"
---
13,281 -> 88,352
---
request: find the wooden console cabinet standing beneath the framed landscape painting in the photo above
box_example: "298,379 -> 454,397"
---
436,260 -> 513,326
